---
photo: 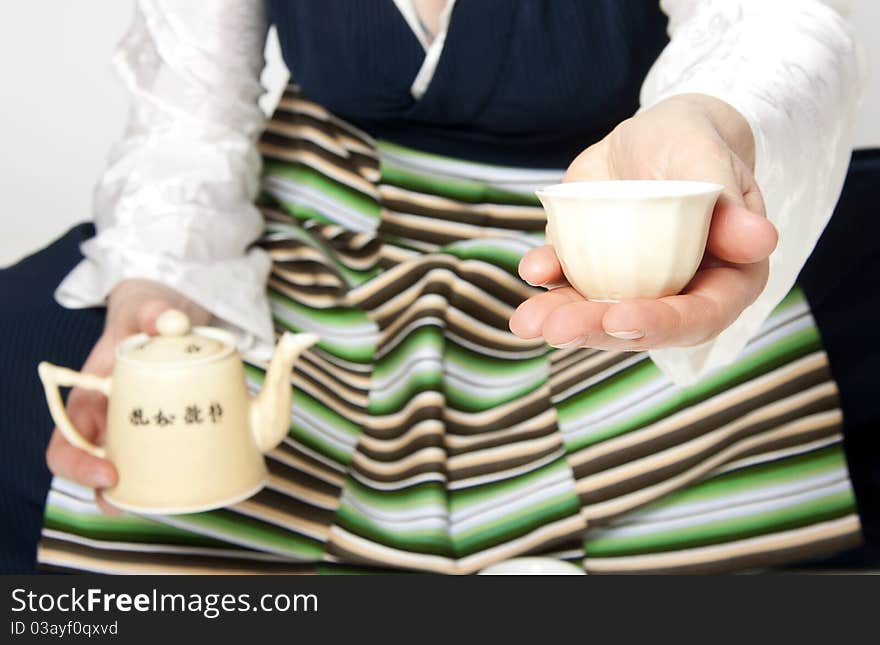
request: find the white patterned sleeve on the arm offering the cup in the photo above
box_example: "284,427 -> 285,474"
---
641,0 -> 865,384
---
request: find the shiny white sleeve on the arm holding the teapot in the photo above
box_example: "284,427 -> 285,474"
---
56,0 -> 273,348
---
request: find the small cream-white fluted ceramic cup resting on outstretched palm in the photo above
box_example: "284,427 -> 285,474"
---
536,180 -> 723,302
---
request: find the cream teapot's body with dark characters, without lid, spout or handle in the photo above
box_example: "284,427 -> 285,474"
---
104,354 -> 266,514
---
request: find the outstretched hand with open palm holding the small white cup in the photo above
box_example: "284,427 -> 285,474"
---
510,95 -> 777,350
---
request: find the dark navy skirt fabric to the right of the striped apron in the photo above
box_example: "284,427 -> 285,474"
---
798,150 -> 880,562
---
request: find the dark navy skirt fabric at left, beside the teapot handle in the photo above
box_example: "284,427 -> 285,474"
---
0,224 -> 104,573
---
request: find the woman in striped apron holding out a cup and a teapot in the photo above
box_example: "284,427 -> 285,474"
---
3,0 -> 862,573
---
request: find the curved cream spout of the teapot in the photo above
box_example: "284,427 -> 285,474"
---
250,332 -> 319,452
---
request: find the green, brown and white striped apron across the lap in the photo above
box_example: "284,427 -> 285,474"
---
39,87 -> 860,573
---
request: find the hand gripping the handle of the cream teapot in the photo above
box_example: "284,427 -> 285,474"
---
46,279 -> 211,513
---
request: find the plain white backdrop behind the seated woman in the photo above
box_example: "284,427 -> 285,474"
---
0,0 -> 880,266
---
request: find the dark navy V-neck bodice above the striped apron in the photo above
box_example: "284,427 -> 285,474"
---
269,0 -> 667,168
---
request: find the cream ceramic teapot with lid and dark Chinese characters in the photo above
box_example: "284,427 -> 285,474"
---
39,310 -> 318,514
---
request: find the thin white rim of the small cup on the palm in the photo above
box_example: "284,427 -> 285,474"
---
535,179 -> 724,200
